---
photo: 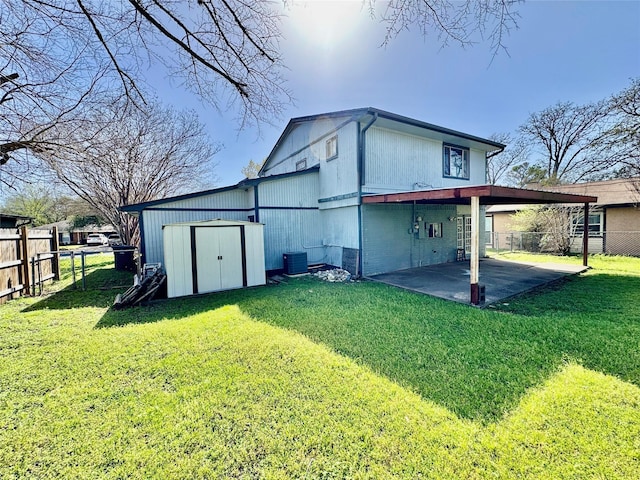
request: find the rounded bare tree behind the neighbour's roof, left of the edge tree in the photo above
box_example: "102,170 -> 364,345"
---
519,101 -> 616,184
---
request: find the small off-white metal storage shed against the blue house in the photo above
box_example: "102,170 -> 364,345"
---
162,219 -> 266,298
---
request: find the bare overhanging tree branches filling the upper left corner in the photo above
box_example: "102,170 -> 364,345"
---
0,0 -> 289,184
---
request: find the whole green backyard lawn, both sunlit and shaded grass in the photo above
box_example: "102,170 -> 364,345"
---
0,256 -> 640,479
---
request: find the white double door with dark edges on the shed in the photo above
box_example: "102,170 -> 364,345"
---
194,227 -> 243,293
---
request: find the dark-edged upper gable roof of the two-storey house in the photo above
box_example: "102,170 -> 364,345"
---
258,107 -> 506,175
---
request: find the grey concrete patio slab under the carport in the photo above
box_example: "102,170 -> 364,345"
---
369,258 -> 588,306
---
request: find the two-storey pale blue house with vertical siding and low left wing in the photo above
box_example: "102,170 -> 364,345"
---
121,108 -> 594,283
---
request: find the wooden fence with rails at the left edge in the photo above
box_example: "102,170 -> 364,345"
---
0,227 -> 60,303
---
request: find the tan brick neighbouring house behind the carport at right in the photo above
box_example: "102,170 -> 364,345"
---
486,178 -> 640,256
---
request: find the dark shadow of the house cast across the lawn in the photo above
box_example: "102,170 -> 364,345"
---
96,275 -> 640,421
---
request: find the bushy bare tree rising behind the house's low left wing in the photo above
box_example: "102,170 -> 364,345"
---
41,100 -> 218,244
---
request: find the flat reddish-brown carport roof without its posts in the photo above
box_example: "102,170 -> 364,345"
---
362,185 -> 598,205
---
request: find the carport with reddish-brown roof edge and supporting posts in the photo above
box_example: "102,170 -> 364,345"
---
362,185 -> 598,305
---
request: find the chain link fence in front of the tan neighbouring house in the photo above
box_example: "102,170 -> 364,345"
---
485,231 -> 640,257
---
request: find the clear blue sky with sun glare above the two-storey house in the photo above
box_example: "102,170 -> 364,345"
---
155,0 -> 640,186
